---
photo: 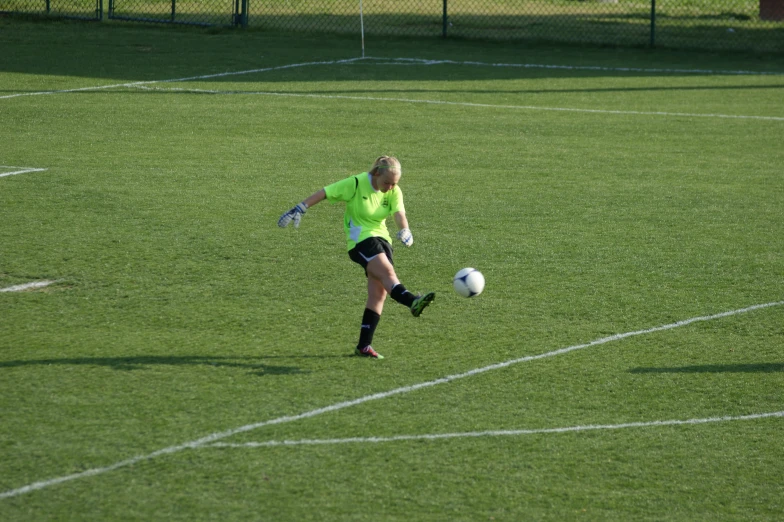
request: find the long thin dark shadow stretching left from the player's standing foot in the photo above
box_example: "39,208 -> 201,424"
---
0,355 -> 321,376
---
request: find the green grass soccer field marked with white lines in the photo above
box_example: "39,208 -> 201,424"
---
0,21 -> 784,521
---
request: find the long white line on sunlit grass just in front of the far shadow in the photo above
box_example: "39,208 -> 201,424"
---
133,85 -> 784,121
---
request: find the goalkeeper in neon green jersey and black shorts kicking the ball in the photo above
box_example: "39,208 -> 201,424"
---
278,156 -> 435,359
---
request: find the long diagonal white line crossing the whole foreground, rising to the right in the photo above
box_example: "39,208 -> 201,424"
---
0,301 -> 784,499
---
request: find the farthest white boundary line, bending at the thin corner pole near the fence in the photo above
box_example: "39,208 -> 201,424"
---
0,57 -> 784,100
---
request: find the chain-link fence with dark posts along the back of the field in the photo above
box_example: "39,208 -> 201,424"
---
0,0 -> 784,52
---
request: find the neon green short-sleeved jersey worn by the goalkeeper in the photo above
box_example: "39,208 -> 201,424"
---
324,172 -> 406,250
